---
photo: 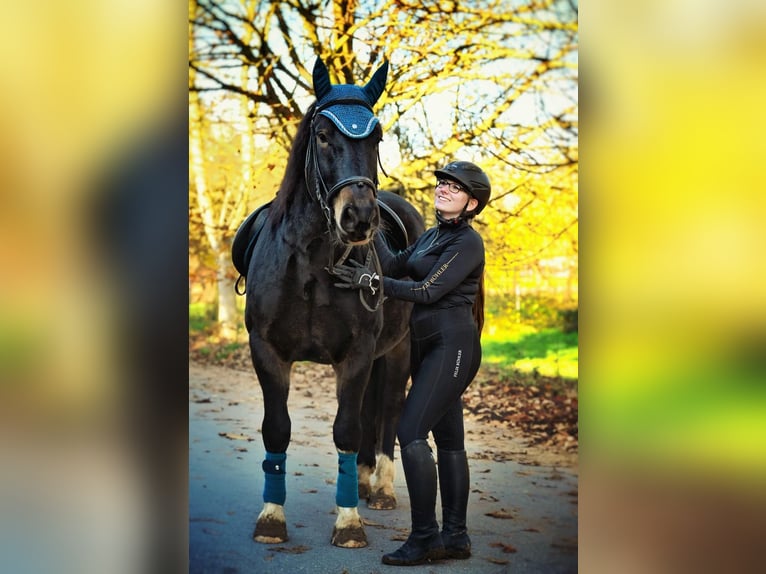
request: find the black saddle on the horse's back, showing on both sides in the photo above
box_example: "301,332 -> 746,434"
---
231,200 -> 409,295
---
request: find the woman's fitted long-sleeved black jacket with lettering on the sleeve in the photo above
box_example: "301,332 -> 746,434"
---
375,220 -> 484,309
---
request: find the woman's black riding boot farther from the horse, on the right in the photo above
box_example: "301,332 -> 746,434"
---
438,449 -> 471,559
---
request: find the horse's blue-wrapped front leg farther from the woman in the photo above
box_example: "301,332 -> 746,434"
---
250,335 -> 291,544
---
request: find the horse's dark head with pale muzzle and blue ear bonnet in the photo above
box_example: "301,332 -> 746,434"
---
306,59 -> 388,245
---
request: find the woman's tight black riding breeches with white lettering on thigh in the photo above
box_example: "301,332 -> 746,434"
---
397,306 -> 481,450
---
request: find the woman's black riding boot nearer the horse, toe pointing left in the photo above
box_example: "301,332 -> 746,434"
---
383,439 -> 445,566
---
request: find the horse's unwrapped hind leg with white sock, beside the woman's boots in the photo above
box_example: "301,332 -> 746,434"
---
367,335 -> 410,510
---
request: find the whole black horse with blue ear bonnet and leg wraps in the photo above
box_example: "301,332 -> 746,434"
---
233,59 -> 424,547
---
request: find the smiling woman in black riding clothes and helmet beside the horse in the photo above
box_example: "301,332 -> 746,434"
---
336,161 -> 490,566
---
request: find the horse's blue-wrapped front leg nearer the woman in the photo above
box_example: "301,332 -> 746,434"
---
332,358 -> 373,548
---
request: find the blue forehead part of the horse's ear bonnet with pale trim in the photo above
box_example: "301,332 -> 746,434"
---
317,84 -> 378,139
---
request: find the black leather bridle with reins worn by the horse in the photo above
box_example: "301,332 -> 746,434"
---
304,99 -> 385,312
